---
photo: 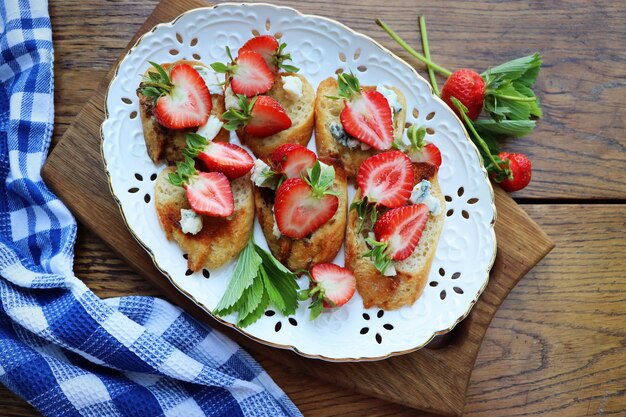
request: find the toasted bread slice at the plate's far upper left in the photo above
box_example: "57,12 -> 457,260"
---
137,60 -> 230,164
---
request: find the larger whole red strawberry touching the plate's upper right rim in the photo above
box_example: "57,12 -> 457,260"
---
441,69 -> 485,120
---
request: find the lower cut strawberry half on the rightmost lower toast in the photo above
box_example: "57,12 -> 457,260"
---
374,204 -> 429,261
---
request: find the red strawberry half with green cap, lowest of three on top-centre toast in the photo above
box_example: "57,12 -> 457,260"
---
222,95 -> 291,138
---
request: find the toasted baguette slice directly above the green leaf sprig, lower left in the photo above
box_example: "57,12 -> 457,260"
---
154,167 -> 254,271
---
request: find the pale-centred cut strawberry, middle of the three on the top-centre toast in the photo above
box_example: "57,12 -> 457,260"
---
230,51 -> 274,97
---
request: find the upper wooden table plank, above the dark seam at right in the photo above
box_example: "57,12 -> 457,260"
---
50,0 -> 626,200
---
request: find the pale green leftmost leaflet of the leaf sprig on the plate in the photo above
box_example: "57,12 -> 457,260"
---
215,237 -> 263,315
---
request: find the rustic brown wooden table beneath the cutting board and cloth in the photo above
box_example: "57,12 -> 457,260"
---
0,0 -> 626,416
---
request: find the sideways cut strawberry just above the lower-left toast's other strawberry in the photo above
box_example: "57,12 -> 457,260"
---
198,142 -> 254,180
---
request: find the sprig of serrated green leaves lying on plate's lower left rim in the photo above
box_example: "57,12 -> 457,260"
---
213,237 -> 298,327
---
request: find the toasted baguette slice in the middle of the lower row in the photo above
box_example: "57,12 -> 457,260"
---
254,159 -> 348,271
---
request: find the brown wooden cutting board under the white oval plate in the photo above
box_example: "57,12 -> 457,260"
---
42,0 -> 554,415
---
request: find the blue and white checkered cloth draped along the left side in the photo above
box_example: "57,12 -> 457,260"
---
0,0 -> 300,417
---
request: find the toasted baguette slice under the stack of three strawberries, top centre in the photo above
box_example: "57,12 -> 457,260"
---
237,72 -> 315,160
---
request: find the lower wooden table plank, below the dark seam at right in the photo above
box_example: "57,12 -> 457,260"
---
0,205 -> 626,417
